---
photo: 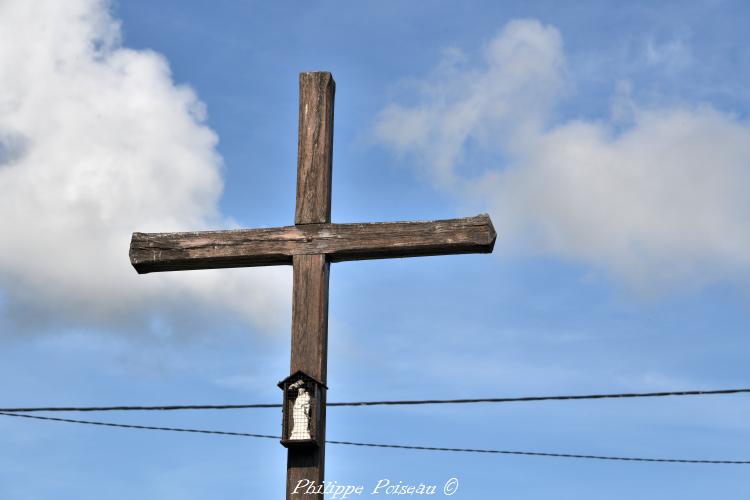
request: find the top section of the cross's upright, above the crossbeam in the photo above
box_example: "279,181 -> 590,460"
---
294,72 -> 336,224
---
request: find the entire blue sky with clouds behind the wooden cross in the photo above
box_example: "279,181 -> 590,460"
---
0,0 -> 750,500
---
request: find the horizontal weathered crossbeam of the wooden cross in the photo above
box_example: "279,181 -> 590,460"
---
130,214 -> 496,273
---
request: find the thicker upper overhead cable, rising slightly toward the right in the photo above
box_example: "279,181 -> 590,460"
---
0,389 -> 750,413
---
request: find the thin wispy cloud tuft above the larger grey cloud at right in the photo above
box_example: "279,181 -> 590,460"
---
375,21 -> 565,186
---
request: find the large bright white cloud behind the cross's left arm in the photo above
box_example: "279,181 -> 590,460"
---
0,0 -> 289,336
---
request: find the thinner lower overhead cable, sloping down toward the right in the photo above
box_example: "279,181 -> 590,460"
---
0,412 -> 750,465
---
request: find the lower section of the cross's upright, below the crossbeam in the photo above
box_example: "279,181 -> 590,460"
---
286,254 -> 330,500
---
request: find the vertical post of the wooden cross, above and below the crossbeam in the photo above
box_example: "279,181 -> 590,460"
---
286,73 -> 336,500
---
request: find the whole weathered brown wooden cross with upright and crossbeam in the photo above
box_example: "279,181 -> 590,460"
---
130,72 -> 495,500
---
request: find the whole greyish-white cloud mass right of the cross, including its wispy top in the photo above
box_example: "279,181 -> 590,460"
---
375,20 -> 750,292
